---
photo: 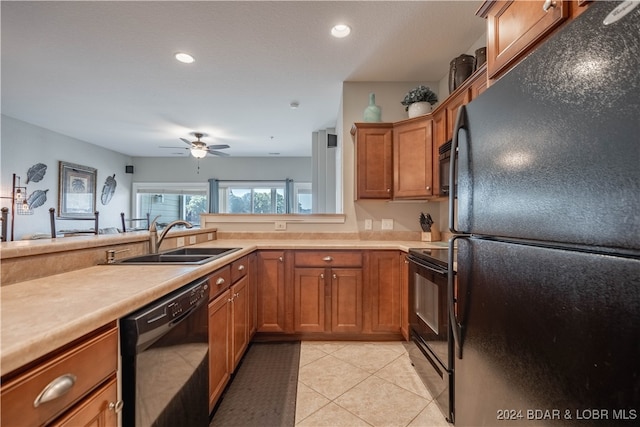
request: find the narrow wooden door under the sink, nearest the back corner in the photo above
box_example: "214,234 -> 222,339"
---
230,276 -> 249,372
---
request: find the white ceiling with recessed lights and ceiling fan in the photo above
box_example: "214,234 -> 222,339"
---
1,1 -> 485,157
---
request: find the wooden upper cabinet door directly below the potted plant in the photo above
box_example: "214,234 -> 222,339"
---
393,116 -> 434,199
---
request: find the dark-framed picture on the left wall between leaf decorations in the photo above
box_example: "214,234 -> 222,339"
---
58,161 -> 98,218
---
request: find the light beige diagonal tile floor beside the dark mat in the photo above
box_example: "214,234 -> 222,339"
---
296,341 -> 451,427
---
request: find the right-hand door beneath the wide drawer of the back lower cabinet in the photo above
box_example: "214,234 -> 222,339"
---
329,268 -> 362,332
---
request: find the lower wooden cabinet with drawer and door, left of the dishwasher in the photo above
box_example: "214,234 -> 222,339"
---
0,322 -> 122,427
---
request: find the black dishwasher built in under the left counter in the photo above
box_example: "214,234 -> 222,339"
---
120,278 -> 209,427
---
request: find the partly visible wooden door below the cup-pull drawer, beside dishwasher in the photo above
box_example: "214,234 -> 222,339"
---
51,376 -> 118,427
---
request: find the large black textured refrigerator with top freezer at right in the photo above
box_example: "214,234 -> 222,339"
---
449,1 -> 640,426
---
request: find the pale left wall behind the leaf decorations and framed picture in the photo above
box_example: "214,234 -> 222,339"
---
0,115 -> 131,240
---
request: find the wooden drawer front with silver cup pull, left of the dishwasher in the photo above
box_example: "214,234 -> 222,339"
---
1,327 -> 118,427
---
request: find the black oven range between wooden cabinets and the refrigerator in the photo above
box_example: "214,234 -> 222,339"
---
407,248 -> 453,422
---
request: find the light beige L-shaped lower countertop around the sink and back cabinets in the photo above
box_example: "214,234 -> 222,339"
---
0,239 -> 443,375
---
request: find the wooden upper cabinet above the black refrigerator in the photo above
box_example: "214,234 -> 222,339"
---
477,0 -> 571,79
